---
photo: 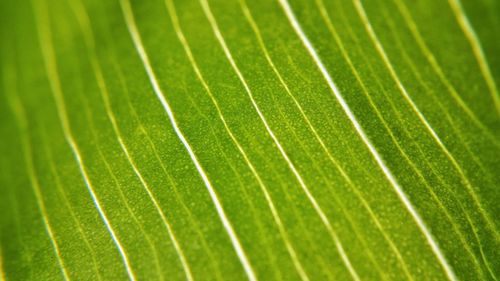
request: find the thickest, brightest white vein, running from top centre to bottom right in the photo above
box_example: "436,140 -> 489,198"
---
279,0 -> 456,280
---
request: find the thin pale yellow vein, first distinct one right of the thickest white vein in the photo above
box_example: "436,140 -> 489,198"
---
353,0 -> 496,240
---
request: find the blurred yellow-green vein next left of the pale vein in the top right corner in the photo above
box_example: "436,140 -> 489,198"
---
394,0 -> 500,146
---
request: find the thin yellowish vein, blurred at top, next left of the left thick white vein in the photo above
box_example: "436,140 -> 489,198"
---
69,0 -> 188,280
